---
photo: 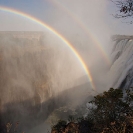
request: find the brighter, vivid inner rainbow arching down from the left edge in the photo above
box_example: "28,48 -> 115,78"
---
0,6 -> 95,90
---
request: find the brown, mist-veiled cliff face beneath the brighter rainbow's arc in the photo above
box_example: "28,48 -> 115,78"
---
0,32 -> 90,132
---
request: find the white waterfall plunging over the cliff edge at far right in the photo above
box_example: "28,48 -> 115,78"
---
109,36 -> 133,89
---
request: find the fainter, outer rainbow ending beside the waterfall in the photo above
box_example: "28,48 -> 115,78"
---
50,0 -> 111,66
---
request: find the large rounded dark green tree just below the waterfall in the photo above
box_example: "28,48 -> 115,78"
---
88,88 -> 133,132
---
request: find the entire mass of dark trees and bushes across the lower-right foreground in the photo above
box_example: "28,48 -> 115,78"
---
52,88 -> 133,133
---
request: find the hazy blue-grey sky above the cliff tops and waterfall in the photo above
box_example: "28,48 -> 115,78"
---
0,0 -> 133,36
